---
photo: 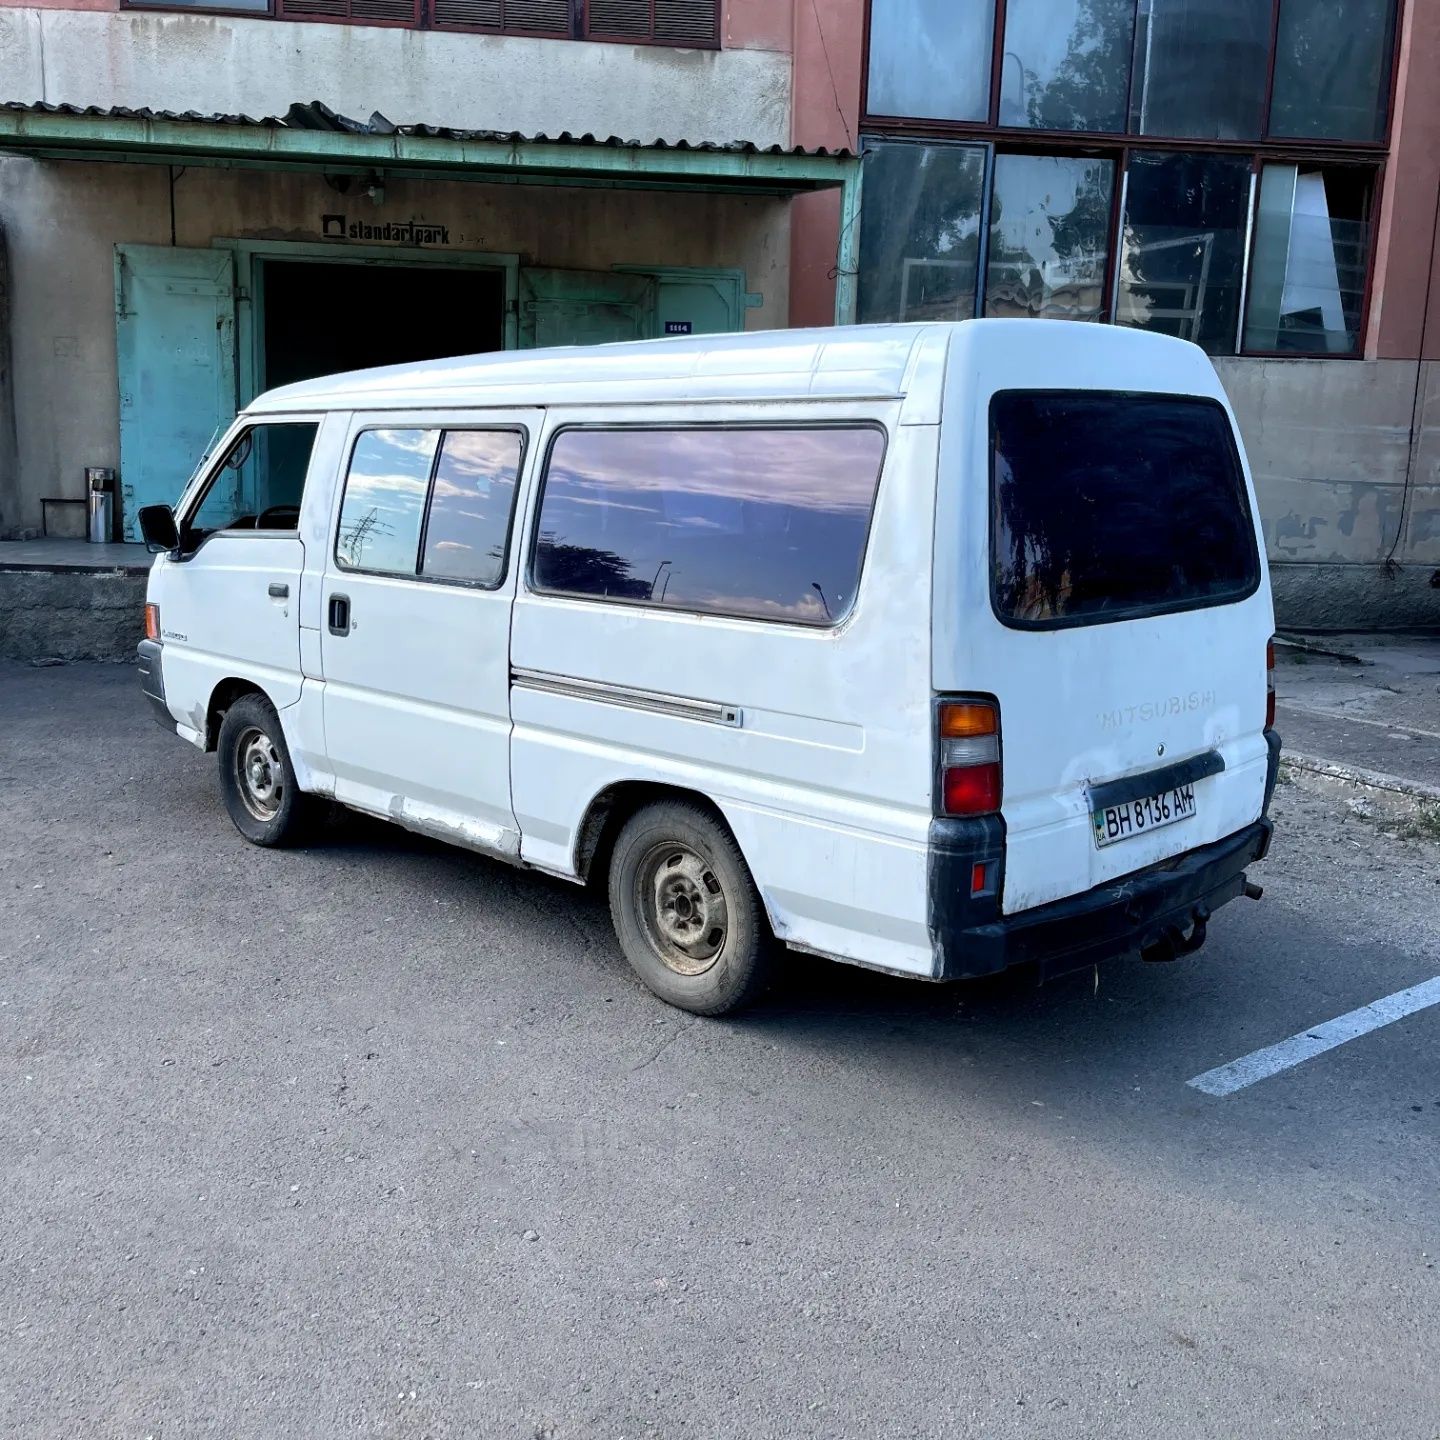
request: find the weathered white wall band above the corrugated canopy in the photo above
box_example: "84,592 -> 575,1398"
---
0,7 -> 791,145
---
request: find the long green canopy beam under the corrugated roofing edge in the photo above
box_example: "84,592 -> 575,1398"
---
0,109 -> 860,198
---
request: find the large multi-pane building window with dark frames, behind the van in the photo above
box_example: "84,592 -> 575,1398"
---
858,0 -> 1398,356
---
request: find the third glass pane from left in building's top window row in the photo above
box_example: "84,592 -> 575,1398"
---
1130,0 -> 1272,140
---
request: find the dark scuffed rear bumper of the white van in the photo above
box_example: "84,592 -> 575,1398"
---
930,819 -> 1273,981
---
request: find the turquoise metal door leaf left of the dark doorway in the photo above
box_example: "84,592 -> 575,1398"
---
115,245 -> 235,540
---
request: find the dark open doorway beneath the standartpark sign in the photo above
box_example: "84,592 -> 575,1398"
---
262,261 -> 505,389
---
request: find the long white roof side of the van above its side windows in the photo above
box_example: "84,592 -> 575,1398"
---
246,321 -> 956,413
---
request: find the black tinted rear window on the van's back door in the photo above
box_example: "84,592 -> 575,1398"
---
991,390 -> 1260,629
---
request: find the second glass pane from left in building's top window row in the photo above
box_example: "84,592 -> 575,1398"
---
999,0 -> 1135,131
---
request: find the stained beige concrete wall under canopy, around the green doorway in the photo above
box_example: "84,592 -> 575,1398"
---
0,158 -> 789,537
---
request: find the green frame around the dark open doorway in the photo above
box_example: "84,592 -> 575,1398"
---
210,238 -> 520,408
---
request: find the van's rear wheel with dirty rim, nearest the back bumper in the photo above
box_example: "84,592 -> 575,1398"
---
609,801 -> 776,1015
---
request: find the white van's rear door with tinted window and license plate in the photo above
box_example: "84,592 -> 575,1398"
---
936,327 -> 1273,913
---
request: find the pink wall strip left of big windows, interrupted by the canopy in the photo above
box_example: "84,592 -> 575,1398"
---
791,0 -> 865,325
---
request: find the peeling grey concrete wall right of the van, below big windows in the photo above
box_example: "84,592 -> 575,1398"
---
1215,360 -> 1440,629
